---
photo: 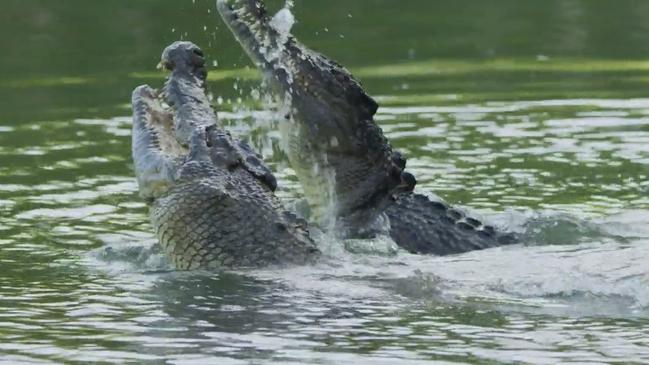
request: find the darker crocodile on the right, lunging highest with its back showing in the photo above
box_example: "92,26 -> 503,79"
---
217,0 -> 519,255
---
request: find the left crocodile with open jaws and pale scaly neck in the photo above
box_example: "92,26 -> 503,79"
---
132,42 -> 320,270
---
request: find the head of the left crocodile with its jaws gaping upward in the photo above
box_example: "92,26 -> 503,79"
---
132,42 -> 277,198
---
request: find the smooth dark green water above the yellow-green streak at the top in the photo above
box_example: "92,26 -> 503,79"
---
6,0 -> 649,74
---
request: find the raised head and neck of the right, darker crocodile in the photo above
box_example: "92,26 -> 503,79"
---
217,0 -> 416,234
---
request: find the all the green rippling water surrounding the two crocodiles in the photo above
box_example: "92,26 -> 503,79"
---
0,0 -> 649,364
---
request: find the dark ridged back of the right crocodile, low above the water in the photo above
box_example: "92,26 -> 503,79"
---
386,193 -> 518,255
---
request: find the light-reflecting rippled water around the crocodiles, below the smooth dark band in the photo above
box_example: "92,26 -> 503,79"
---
0,99 -> 649,364
